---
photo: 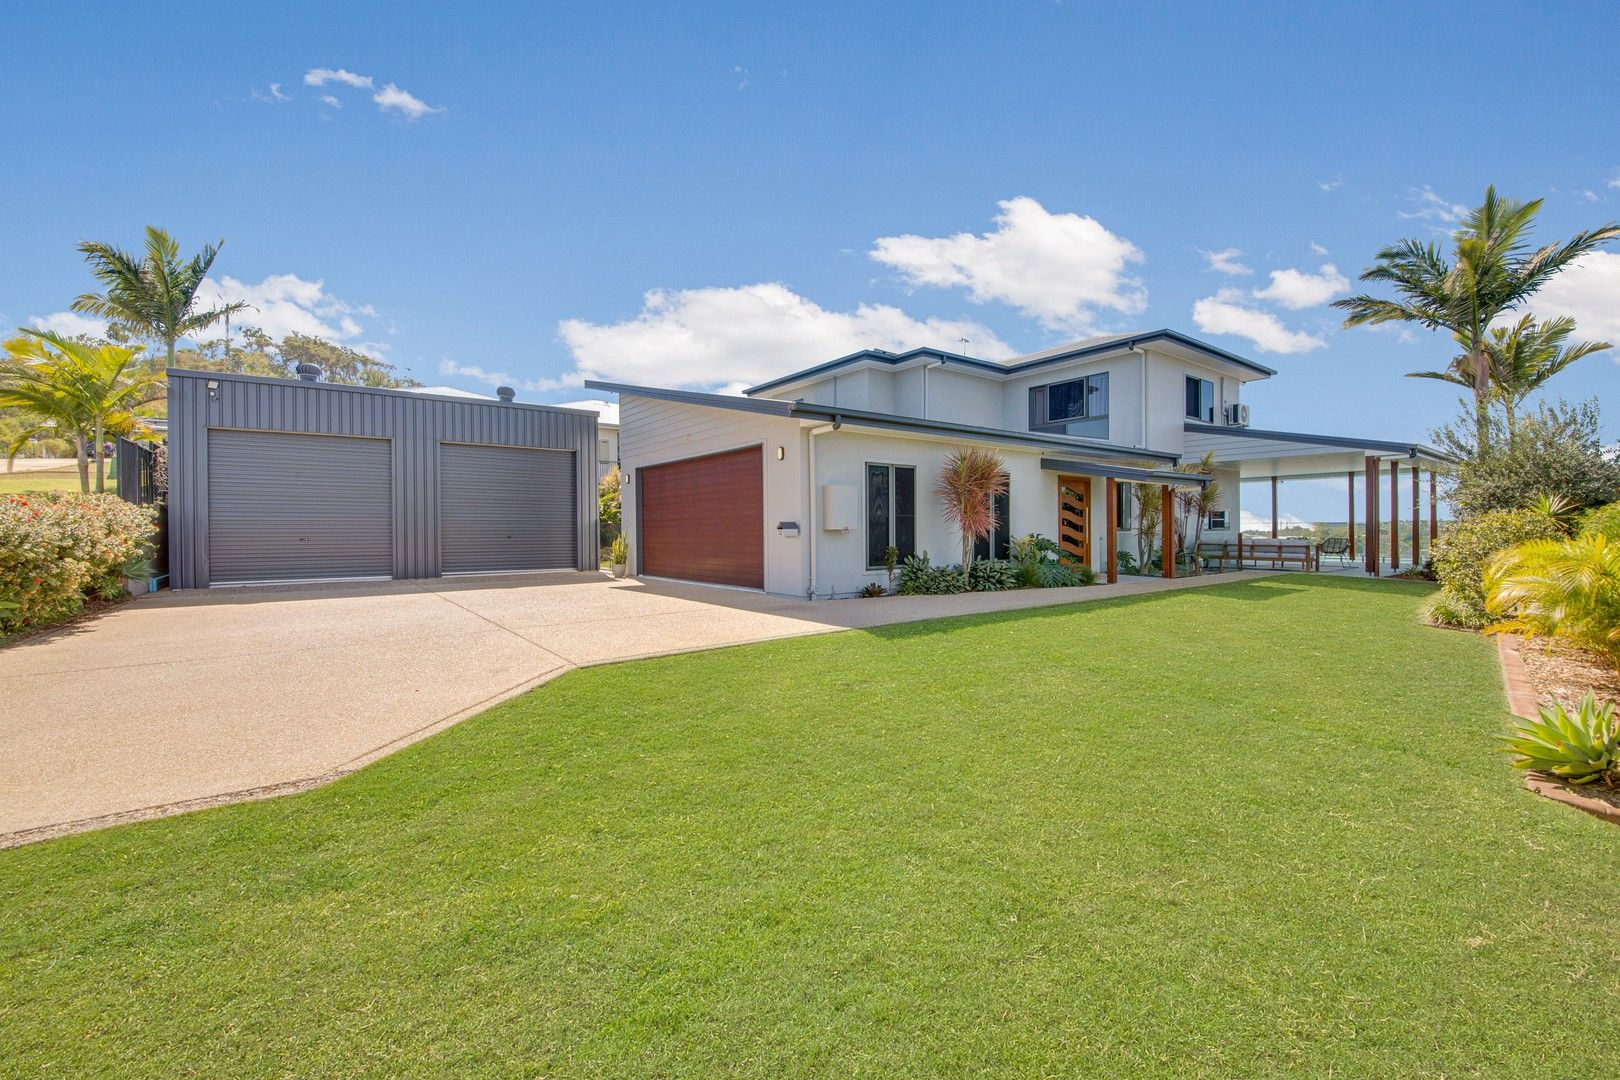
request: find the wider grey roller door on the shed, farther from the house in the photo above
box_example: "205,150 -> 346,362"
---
207,431 -> 394,585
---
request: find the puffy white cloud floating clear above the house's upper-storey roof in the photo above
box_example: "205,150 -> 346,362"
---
870,196 -> 1147,332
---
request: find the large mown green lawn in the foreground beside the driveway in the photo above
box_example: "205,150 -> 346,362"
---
0,575 -> 1620,1078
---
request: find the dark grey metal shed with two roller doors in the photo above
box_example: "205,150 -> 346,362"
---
168,369 -> 598,589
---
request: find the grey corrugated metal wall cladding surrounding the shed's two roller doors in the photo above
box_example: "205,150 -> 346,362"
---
168,369 -> 598,589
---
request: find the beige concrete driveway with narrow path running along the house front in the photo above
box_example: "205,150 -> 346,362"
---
0,572 -> 1265,847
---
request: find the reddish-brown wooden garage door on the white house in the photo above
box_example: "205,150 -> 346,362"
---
638,447 -> 765,589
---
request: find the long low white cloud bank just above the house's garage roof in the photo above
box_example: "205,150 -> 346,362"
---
544,283 -> 1014,390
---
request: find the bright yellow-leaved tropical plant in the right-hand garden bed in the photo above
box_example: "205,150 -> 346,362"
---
1484,533 -> 1620,667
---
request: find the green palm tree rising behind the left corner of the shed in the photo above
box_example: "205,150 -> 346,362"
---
73,225 -> 248,368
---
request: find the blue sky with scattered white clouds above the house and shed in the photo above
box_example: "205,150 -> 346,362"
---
0,3 -> 1620,518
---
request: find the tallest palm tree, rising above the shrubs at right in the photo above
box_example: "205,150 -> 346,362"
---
1333,186 -> 1620,445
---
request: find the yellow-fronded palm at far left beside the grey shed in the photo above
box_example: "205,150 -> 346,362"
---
0,330 -> 164,492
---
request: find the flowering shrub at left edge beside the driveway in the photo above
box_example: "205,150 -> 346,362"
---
0,491 -> 154,633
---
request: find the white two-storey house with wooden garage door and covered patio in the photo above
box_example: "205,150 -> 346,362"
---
586,330 -> 1435,597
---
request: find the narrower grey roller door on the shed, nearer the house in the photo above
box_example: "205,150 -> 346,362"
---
439,442 -> 580,573
